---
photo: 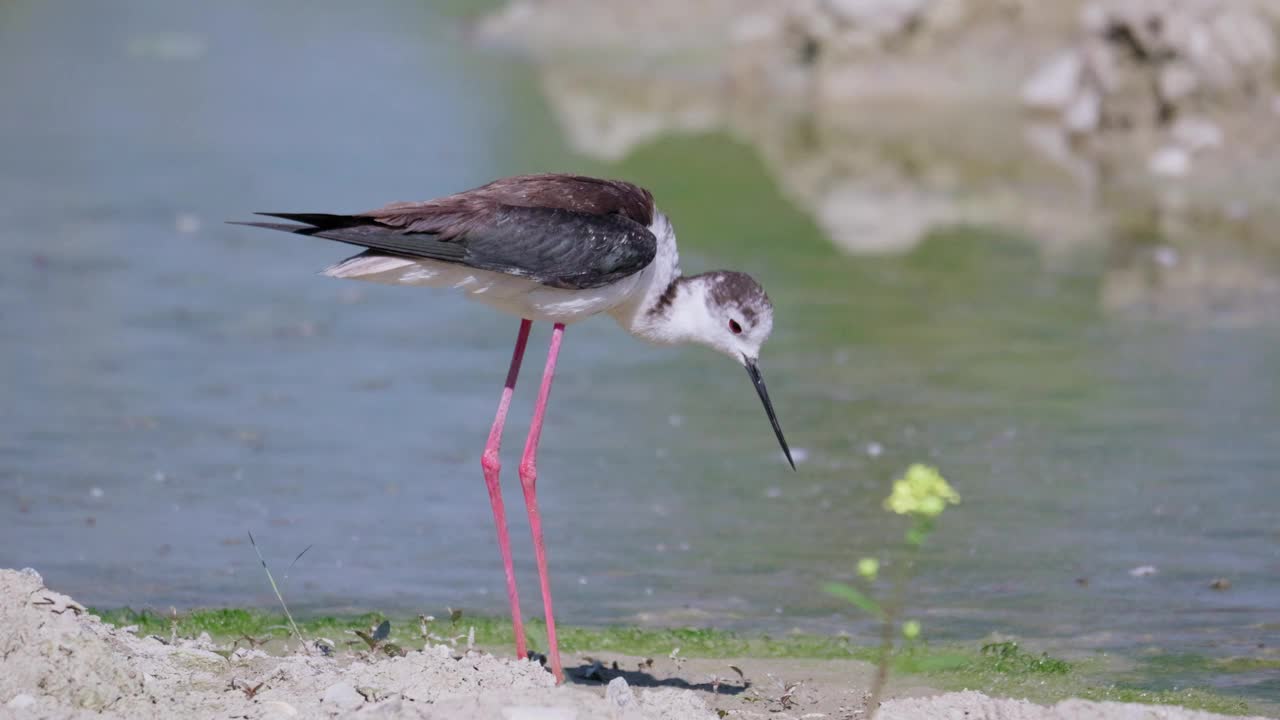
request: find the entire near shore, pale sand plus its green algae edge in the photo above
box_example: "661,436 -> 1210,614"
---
0,570 -> 1266,720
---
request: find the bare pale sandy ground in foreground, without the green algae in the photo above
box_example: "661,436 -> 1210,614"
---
0,570 -> 1269,720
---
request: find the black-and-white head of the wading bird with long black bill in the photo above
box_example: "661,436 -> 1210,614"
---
646,270 -> 795,468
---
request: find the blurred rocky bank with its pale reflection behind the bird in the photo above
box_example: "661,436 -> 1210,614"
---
476,0 -> 1280,320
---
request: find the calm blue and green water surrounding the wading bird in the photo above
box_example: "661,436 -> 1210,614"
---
0,0 -> 1280,700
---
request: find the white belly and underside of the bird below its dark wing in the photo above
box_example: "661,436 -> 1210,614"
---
324,255 -> 650,324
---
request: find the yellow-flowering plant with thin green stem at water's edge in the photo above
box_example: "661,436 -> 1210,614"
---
823,464 -> 957,717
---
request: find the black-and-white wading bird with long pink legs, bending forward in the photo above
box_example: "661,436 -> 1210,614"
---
231,174 -> 795,682
